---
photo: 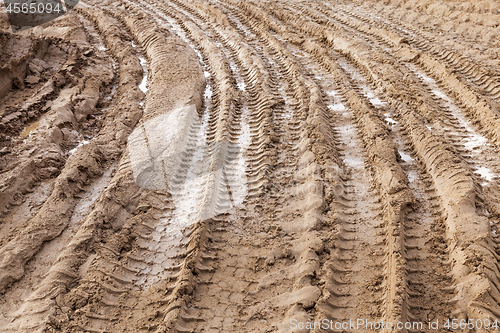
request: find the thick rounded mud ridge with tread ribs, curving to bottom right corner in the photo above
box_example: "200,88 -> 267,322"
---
320,29 -> 497,330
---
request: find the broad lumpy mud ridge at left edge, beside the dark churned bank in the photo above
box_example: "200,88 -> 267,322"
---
0,37 -> 113,215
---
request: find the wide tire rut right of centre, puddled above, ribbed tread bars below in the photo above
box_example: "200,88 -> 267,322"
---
298,48 -> 385,330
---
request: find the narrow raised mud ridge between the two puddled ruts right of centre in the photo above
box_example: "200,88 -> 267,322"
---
310,46 -> 413,322
